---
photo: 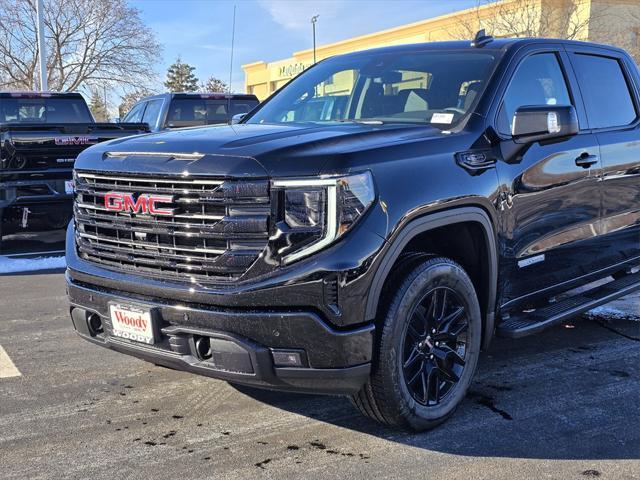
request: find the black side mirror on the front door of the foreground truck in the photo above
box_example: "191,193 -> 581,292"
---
511,105 -> 580,144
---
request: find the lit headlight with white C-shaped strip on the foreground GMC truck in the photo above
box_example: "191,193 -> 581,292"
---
273,172 -> 375,263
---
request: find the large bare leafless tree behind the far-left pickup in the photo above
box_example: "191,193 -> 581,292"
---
0,0 -> 161,91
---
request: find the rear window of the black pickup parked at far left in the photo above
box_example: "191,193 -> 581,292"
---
0,98 -> 93,123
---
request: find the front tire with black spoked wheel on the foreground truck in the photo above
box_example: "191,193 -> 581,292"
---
351,257 -> 482,431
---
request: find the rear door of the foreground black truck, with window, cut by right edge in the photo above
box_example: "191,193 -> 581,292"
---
569,52 -> 640,268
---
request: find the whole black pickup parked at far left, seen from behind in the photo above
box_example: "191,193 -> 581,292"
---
0,92 -> 148,253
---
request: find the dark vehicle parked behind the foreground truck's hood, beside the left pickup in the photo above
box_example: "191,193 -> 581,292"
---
123,93 -> 260,132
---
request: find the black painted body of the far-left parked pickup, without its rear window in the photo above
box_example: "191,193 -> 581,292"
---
0,92 -> 148,253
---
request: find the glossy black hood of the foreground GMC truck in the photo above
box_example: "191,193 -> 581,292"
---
76,123 -> 443,177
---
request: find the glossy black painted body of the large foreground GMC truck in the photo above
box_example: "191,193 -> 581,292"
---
67,39 -> 640,393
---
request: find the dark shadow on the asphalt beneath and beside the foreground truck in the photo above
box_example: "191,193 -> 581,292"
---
236,316 -> 640,460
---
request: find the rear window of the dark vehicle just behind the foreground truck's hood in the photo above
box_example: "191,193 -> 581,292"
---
167,98 -> 229,127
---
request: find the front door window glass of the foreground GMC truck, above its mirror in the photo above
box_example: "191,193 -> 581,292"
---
498,53 -> 571,135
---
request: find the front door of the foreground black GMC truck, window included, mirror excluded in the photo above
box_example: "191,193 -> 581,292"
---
496,51 -> 602,306
